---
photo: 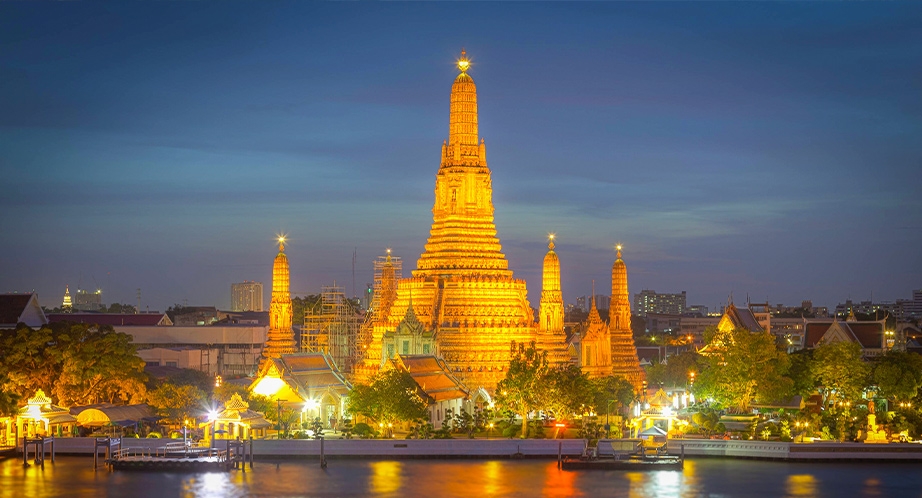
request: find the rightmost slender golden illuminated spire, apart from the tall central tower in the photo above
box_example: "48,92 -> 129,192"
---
608,245 -> 646,391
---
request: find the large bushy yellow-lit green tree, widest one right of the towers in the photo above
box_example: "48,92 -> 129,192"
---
695,328 -> 793,412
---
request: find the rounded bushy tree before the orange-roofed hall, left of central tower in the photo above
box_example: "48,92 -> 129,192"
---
347,370 -> 429,424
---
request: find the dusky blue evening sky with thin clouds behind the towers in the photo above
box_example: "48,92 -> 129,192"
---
0,2 -> 922,311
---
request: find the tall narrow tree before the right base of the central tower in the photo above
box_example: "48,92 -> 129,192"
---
496,342 -> 548,438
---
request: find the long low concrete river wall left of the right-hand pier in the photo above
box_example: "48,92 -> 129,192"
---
39,438 -> 586,460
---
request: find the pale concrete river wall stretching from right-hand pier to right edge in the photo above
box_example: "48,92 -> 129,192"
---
668,439 -> 922,461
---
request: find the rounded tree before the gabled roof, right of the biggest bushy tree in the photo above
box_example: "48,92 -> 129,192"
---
813,341 -> 868,407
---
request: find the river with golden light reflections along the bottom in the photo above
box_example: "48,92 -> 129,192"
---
0,456 -> 922,498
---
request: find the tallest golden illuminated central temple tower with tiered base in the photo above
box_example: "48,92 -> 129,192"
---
375,51 -> 563,390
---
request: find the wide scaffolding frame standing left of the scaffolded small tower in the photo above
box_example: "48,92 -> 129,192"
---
301,282 -> 362,372
